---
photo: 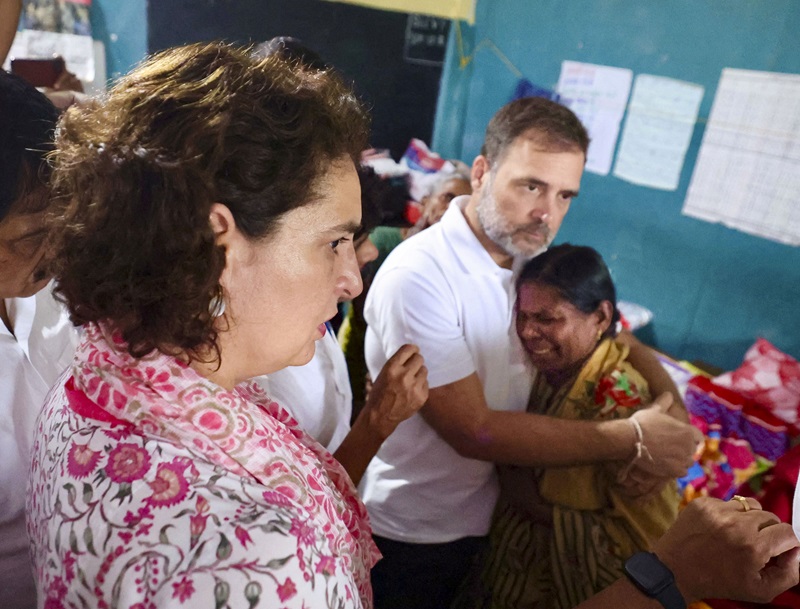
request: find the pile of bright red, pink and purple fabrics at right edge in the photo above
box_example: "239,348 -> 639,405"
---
678,338 -> 800,609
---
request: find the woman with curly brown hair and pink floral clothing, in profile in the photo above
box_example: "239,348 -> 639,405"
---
28,44 -> 425,608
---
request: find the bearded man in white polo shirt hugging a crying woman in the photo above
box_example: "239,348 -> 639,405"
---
361,98 -> 697,609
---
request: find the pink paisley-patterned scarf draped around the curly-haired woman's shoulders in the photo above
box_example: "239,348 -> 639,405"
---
68,324 -> 380,606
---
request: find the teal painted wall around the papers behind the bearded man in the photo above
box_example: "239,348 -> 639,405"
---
433,0 -> 800,368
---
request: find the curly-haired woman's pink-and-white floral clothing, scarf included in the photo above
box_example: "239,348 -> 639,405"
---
28,325 -> 380,609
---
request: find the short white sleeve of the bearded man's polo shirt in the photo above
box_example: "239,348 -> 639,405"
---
364,264 -> 475,387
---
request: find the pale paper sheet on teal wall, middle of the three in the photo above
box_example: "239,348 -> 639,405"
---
614,74 -> 703,190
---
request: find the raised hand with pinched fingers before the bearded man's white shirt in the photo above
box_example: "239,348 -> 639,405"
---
364,345 -> 428,440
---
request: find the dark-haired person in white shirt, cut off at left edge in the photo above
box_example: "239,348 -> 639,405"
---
0,70 -> 77,609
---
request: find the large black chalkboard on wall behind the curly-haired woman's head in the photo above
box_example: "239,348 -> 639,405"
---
147,0 -> 446,158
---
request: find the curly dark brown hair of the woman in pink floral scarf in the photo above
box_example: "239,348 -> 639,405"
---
53,43 -> 368,359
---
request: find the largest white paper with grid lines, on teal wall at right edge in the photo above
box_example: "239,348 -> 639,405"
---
683,68 -> 800,245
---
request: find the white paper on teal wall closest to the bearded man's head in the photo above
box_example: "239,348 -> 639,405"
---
558,61 -> 633,175
